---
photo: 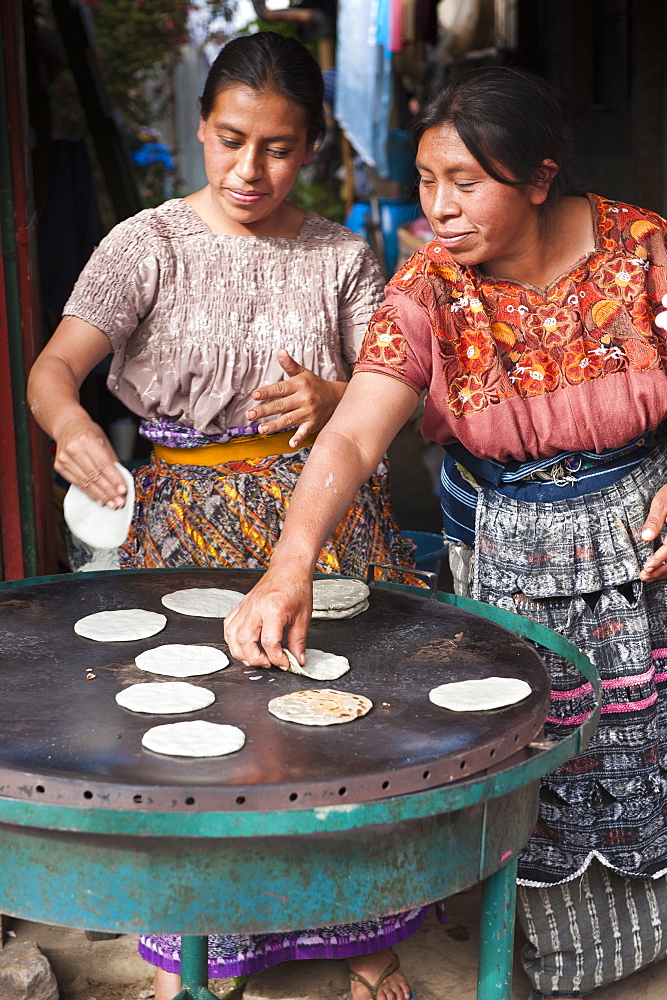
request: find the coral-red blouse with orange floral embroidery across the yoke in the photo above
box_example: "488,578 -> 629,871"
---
355,195 -> 667,462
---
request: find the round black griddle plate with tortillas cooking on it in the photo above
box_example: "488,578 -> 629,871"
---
0,570 -> 549,810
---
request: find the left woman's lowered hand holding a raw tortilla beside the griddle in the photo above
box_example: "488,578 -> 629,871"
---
54,412 -> 127,508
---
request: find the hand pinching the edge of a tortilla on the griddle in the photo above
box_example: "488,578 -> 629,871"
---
224,566 -> 313,670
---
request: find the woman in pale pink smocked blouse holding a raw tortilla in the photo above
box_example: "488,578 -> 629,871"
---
29,32 -> 425,1000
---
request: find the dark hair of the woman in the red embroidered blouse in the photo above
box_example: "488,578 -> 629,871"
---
412,66 -> 572,208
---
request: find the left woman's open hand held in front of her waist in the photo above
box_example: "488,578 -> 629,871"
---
246,348 -> 346,448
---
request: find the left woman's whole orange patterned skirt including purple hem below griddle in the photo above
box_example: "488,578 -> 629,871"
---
120,448 -> 428,979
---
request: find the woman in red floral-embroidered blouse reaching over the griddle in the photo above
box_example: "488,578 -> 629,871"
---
225,68 -> 667,1000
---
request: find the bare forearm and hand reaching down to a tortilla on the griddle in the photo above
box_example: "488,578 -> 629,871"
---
225,372 -> 418,667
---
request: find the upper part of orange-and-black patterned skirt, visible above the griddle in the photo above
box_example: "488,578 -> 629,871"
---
120,448 -> 420,583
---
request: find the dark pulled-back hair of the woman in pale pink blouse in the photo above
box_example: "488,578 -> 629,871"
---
199,31 -> 326,142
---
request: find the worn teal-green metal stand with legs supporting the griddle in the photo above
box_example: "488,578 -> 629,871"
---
0,574 -> 602,1000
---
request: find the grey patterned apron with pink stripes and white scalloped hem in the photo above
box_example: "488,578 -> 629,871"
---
473,446 -> 667,886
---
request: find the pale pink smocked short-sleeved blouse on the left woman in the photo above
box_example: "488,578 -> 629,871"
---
63,199 -> 384,435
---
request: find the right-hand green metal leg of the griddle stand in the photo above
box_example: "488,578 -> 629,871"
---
477,857 -> 517,1000
